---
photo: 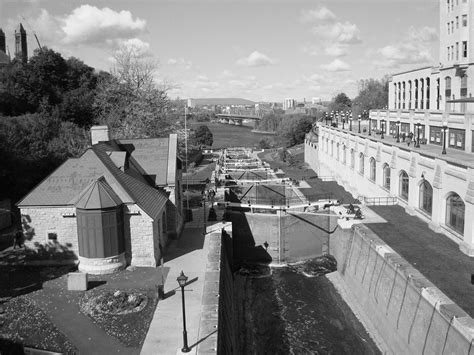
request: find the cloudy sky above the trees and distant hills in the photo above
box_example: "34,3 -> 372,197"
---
0,0 -> 439,102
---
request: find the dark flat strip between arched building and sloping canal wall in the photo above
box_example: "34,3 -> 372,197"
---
367,206 -> 474,317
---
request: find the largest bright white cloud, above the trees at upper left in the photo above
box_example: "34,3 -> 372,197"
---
61,5 -> 146,44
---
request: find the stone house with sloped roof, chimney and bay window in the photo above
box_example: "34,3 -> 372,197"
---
17,126 -> 183,273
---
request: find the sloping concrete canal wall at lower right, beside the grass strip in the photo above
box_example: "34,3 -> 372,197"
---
329,225 -> 474,354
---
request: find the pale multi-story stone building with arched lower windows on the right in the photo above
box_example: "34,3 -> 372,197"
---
305,0 -> 474,256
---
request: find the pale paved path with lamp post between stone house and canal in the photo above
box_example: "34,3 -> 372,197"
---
141,207 -> 223,355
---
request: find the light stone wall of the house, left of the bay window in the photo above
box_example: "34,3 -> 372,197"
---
20,207 -> 79,255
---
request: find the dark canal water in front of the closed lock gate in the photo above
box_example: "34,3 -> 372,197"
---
234,259 -> 380,354
